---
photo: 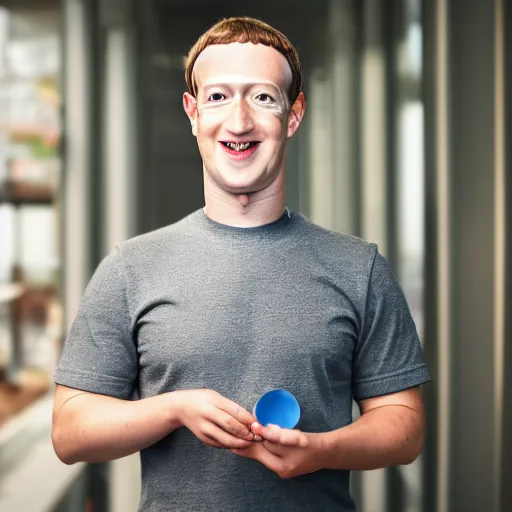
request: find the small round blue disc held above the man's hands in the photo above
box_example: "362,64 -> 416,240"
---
254,389 -> 300,428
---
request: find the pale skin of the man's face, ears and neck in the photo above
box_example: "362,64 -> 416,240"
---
183,43 -> 306,227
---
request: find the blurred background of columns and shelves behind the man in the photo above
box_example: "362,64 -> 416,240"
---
0,0 -> 512,512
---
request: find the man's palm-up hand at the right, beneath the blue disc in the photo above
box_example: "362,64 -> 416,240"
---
230,422 -> 323,479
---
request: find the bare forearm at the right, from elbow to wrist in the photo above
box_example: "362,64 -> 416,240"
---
318,405 -> 424,470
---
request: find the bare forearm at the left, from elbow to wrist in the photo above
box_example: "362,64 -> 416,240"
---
52,392 -> 180,464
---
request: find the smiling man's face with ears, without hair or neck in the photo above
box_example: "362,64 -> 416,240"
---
184,43 -> 305,194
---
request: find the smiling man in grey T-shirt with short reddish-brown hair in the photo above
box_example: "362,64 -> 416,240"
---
53,18 -> 429,512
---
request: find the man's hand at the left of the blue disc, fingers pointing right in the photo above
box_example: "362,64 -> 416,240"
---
175,389 -> 254,448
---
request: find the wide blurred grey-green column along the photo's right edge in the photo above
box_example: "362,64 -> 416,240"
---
424,0 -> 512,512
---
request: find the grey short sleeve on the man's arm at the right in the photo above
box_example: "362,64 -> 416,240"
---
352,251 -> 430,401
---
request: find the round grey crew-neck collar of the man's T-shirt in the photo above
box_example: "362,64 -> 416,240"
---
190,208 -> 297,240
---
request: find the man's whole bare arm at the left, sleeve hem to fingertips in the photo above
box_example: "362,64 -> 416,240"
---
52,385 -> 254,464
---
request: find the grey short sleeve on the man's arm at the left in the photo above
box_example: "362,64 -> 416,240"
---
54,248 -> 138,399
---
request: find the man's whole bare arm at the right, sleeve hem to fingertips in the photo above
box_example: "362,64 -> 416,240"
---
231,387 -> 425,478
